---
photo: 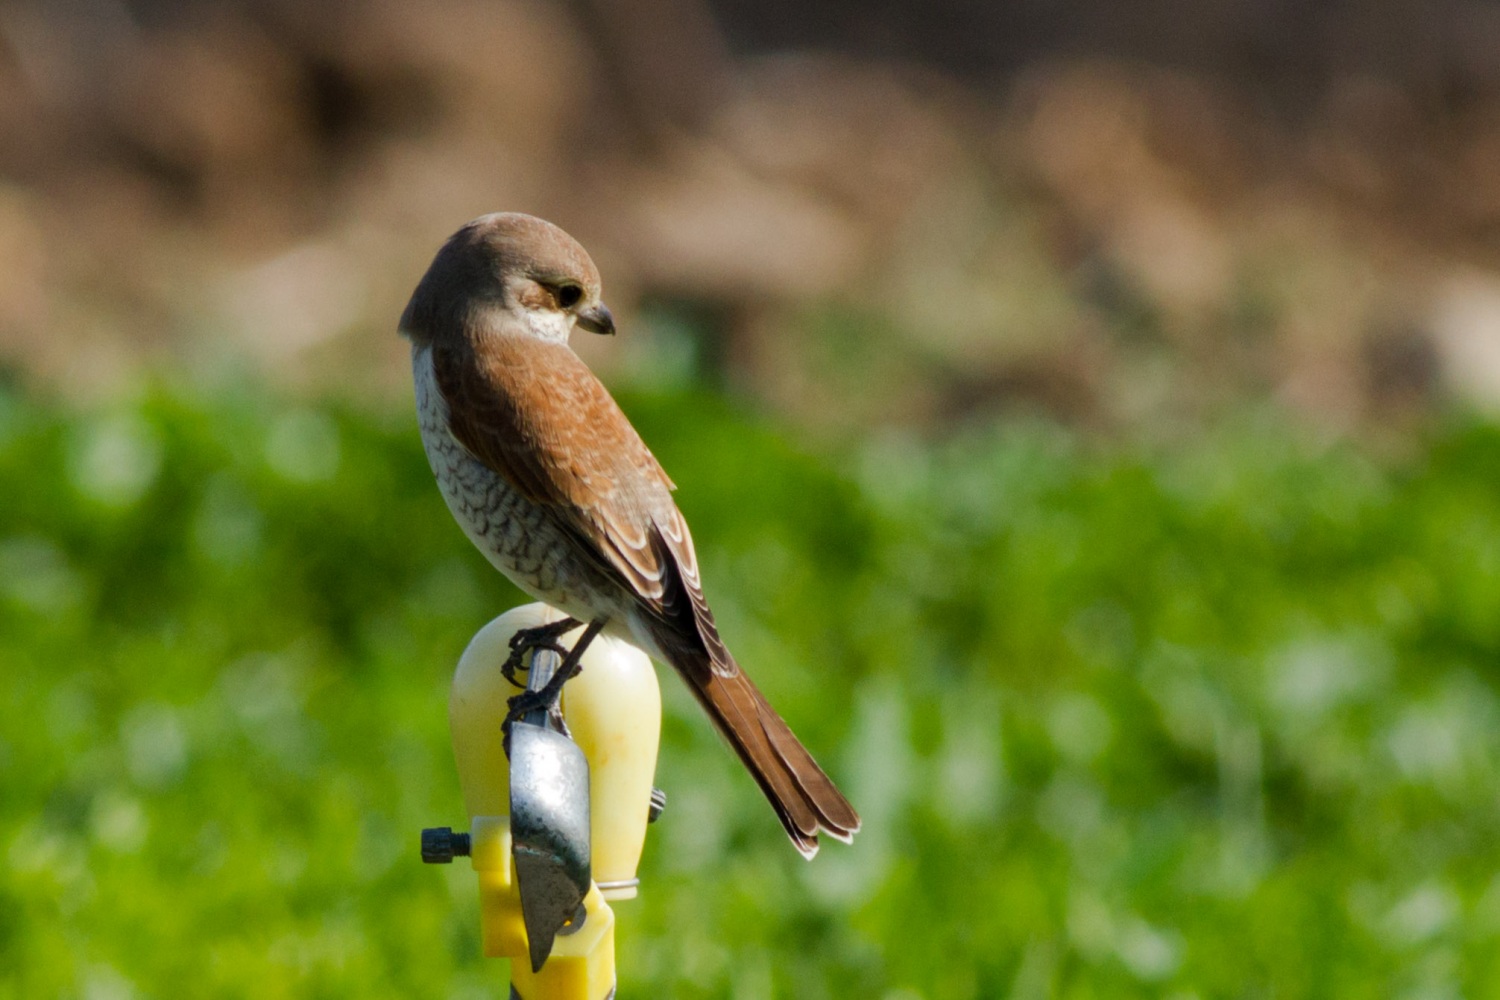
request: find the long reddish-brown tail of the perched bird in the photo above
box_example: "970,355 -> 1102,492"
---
674,657 -> 860,858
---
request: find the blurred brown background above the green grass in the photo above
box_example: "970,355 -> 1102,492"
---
0,0 -> 1500,429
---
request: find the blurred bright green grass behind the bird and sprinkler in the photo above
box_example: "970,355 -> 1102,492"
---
0,379 -> 1500,1000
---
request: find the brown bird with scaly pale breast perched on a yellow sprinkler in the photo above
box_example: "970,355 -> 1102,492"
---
399,213 -> 860,858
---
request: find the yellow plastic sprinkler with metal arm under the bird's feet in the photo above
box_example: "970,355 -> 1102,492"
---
422,604 -> 665,1000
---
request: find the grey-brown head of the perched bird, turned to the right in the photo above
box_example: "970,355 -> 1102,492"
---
401,211 -> 615,343
